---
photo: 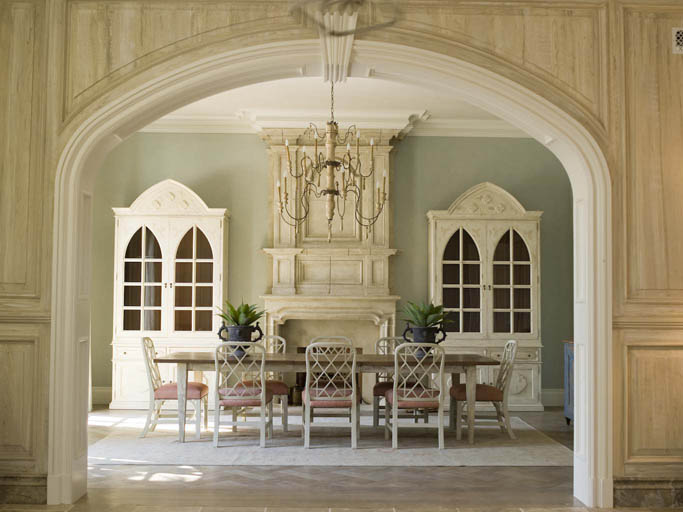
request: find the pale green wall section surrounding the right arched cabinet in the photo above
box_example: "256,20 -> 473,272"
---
391,137 -> 573,388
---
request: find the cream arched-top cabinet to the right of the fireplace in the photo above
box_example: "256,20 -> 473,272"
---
427,183 -> 543,410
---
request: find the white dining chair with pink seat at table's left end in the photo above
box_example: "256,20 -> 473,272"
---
140,337 -> 209,439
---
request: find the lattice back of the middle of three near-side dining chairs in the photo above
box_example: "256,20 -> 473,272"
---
306,336 -> 356,401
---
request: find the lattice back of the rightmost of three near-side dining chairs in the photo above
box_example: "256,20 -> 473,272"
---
394,342 -> 445,402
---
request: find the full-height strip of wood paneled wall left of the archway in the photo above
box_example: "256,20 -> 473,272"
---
0,0 -> 53,488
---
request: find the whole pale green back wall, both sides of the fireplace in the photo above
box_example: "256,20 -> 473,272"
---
92,133 -> 572,388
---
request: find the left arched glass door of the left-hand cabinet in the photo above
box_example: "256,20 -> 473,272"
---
123,226 -> 163,331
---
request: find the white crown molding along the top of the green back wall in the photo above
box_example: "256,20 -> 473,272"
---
140,111 -> 531,138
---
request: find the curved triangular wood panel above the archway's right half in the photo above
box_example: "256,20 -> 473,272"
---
368,0 -> 607,129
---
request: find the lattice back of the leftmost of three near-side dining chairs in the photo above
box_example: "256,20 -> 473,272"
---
214,341 -> 266,401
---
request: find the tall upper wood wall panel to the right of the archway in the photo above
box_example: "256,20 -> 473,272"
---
623,6 -> 683,316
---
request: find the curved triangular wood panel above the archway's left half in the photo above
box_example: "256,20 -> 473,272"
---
64,0 -> 316,118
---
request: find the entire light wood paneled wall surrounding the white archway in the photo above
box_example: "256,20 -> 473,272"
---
0,0 -> 683,498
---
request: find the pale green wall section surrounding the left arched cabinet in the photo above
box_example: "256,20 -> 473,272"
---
92,133 -> 270,386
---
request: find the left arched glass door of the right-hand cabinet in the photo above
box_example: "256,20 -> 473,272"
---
441,228 -> 482,333
